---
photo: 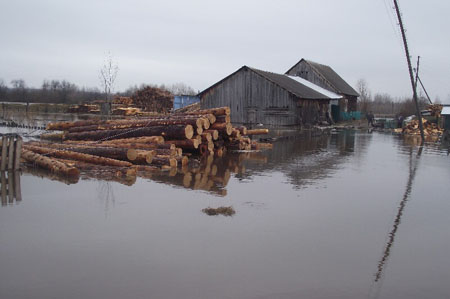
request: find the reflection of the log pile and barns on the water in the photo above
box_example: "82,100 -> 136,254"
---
15,131 -> 364,196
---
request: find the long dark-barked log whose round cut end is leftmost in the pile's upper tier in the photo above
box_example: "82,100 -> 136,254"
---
65,125 -> 194,140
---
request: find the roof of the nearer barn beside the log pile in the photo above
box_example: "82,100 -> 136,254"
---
198,65 -> 341,100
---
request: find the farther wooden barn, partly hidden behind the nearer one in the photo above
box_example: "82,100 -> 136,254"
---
286,58 -> 359,121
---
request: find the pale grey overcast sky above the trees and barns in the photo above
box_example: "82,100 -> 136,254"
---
0,0 -> 450,103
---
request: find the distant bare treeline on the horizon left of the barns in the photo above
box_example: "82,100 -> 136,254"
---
0,79 -> 196,104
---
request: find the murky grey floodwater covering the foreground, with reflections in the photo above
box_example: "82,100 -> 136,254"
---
0,116 -> 450,299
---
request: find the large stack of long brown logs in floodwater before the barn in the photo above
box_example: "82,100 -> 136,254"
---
22,107 -> 271,182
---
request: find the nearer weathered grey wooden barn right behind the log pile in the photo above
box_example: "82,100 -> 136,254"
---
198,66 -> 341,126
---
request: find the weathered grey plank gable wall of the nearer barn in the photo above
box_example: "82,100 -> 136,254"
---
201,68 -> 302,126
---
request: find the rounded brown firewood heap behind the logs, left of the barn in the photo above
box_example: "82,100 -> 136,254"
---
131,86 -> 174,113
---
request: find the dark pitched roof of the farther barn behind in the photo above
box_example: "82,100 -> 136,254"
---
286,58 -> 359,97
